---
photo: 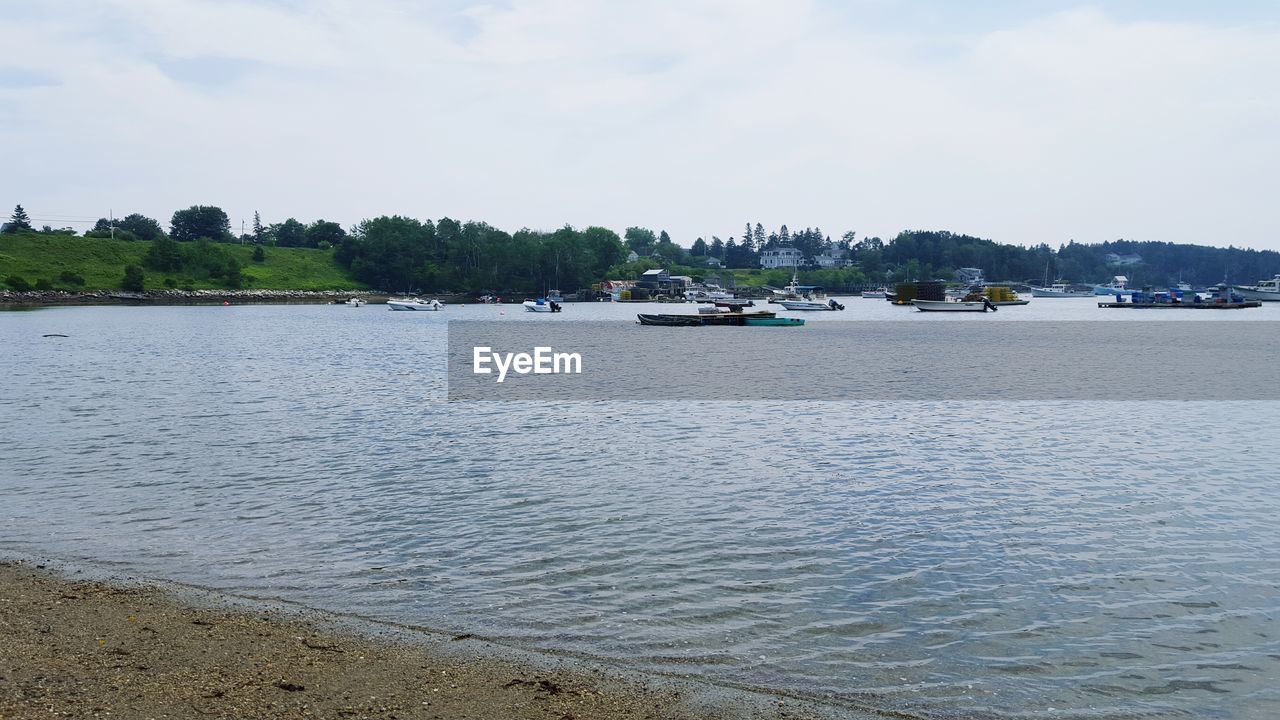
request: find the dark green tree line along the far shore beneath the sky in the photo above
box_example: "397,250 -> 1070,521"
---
4,205 -> 1280,292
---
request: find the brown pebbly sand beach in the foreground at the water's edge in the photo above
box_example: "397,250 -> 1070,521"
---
0,559 -> 875,720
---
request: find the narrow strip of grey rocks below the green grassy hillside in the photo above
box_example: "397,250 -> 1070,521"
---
0,290 -> 387,306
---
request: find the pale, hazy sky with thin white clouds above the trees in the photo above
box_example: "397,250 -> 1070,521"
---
0,0 -> 1280,250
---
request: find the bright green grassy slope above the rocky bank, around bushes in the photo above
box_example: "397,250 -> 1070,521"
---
0,233 -> 366,290
